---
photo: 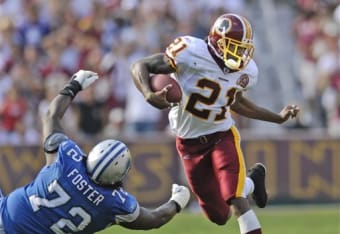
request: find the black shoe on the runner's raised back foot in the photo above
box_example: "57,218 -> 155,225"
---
248,163 -> 268,208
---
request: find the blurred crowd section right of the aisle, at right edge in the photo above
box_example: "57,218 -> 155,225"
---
292,0 -> 340,136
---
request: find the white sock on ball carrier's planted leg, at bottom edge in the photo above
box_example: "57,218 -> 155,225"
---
237,210 -> 262,234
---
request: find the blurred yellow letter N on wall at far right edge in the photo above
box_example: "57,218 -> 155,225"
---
289,141 -> 340,199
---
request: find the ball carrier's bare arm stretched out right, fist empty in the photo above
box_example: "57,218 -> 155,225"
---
230,92 -> 300,124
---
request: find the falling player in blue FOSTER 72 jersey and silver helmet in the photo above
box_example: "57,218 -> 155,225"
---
0,70 -> 190,234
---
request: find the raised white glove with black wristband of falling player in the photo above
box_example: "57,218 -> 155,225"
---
59,70 -> 99,99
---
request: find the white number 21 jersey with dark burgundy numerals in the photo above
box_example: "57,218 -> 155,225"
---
165,36 -> 258,138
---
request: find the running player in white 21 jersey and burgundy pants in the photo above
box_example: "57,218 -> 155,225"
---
131,14 -> 299,234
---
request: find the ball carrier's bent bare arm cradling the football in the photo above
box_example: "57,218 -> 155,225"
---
130,53 -> 175,109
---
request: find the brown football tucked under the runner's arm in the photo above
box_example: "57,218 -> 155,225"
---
150,74 -> 182,102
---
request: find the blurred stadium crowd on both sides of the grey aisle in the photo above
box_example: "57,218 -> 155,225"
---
0,0 -> 340,145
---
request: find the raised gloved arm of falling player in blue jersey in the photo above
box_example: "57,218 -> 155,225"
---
42,70 -> 98,165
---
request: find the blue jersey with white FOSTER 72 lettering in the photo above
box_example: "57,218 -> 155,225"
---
1,140 -> 139,234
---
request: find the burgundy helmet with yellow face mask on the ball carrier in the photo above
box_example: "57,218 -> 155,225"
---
208,14 -> 254,71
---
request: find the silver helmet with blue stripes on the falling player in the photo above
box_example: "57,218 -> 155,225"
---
86,140 -> 131,185
